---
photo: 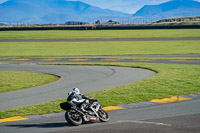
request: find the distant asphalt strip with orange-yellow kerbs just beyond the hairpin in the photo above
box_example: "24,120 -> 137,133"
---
0,54 -> 200,65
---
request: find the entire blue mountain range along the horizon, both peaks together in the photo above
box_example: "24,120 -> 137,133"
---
0,0 -> 200,24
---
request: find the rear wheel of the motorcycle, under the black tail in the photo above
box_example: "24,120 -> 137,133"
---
65,110 -> 83,126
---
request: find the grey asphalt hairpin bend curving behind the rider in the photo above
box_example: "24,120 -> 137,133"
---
0,64 -> 156,110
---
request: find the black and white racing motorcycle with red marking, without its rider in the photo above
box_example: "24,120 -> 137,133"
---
60,99 -> 110,126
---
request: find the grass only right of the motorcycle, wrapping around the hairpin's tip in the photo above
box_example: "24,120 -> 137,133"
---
86,63 -> 200,106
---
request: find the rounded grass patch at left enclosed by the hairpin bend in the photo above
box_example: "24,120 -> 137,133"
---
0,71 -> 58,93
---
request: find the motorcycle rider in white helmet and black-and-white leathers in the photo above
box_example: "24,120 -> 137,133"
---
67,88 -> 90,112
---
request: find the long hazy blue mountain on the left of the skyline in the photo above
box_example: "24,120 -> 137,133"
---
0,0 -> 130,24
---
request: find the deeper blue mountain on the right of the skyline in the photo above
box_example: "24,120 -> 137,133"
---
133,0 -> 200,20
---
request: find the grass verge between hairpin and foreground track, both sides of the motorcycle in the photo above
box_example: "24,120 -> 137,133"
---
0,63 -> 200,118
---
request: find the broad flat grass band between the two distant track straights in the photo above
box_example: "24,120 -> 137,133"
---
0,41 -> 200,58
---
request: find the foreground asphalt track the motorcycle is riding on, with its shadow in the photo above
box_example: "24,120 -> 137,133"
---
0,94 -> 200,133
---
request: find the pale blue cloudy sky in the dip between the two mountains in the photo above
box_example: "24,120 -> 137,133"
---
0,0 -> 200,14
